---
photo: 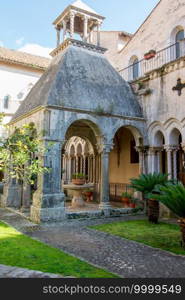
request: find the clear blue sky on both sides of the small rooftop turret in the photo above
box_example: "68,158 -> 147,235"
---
0,0 -> 159,54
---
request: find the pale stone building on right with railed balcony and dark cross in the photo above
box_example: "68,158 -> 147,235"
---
117,0 -> 185,181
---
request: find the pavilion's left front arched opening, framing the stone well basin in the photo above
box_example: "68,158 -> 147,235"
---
62,120 -> 101,211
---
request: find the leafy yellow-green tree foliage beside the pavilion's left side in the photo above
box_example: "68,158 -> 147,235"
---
0,118 -> 48,184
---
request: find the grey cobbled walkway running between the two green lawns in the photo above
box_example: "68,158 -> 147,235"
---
0,210 -> 185,278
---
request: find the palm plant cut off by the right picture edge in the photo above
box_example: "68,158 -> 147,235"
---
153,183 -> 185,248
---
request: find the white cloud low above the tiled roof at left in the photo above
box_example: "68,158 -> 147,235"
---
18,44 -> 53,58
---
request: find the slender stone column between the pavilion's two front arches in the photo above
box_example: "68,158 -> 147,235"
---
100,145 -> 112,214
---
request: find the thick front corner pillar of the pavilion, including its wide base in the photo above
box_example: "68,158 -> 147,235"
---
31,140 -> 65,223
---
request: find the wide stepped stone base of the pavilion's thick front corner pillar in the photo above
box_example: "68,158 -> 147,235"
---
30,192 -> 65,223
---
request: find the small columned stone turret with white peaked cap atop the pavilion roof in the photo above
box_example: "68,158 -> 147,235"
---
53,0 -> 105,47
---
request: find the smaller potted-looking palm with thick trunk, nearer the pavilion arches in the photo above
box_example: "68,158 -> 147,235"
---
131,173 -> 168,224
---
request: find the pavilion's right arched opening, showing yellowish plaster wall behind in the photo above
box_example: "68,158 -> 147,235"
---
109,127 -> 141,207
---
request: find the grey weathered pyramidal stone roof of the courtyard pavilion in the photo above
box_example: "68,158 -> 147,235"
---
12,44 -> 143,121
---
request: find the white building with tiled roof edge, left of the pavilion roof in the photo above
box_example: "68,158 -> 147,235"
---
0,47 -> 50,135
